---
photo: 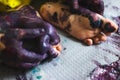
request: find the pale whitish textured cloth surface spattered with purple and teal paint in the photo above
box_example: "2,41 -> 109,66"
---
0,0 -> 120,80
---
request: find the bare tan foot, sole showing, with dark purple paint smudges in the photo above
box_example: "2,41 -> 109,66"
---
40,2 -> 118,45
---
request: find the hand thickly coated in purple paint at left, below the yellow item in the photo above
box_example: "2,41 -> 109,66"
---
0,6 -> 60,69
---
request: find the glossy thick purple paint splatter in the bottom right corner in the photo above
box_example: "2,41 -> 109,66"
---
90,55 -> 120,80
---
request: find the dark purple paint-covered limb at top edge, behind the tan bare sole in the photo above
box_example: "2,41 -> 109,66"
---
61,0 -> 104,15
